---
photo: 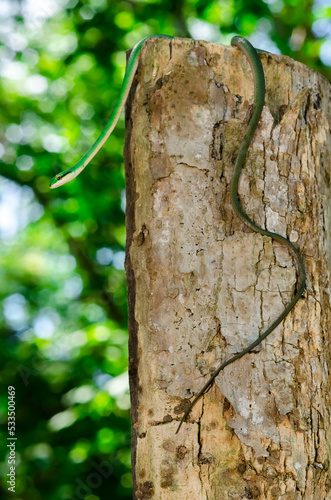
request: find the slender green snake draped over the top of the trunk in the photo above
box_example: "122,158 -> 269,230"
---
50,35 -> 305,434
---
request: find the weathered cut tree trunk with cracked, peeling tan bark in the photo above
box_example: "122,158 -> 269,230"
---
125,39 -> 331,500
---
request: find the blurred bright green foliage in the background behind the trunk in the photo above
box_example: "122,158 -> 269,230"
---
0,0 -> 331,500
